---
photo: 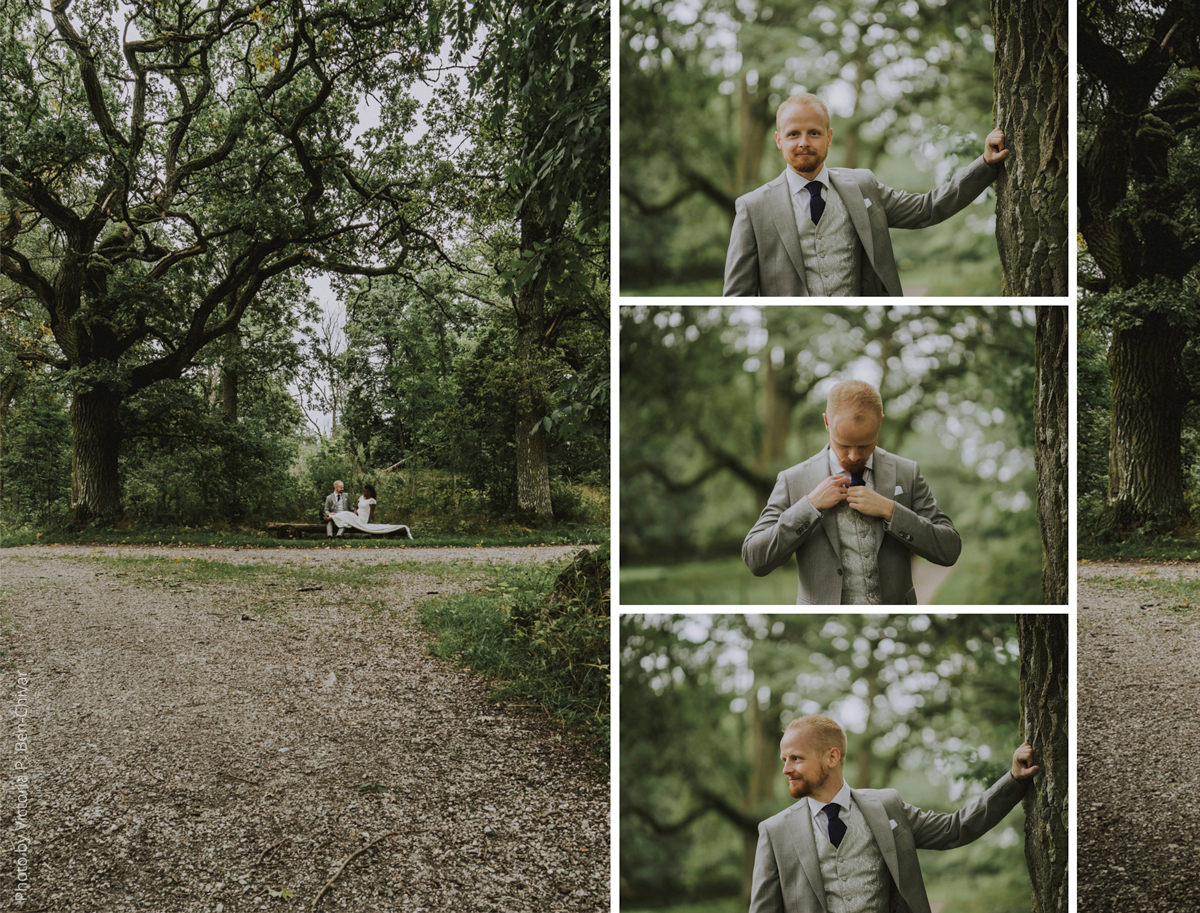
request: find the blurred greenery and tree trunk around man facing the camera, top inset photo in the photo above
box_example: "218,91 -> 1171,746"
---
619,0 -> 1069,296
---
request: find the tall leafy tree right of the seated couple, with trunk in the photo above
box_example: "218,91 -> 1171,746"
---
470,0 -> 610,521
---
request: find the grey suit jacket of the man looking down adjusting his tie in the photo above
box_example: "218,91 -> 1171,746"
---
742,444 -> 962,606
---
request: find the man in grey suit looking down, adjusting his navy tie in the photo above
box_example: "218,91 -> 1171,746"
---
742,380 -> 962,606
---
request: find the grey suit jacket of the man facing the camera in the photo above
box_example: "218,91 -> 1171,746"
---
722,156 -> 997,298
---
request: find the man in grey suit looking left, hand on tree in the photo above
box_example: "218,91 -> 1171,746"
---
750,716 -> 1039,913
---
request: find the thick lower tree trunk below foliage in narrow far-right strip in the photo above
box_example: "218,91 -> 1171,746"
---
1100,313 -> 1188,533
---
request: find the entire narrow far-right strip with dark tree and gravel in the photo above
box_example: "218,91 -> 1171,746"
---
1076,0 -> 1200,913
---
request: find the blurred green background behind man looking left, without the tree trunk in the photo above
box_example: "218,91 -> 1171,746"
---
618,614 -> 1030,913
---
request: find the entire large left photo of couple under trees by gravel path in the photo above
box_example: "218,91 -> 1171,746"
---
0,0 -> 611,913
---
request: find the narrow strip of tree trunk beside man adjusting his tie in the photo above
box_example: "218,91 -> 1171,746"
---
1034,305 -> 1070,606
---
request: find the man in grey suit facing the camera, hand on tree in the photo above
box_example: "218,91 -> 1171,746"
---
724,94 -> 1010,298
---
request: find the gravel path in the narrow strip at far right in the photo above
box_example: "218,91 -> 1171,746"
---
1076,563 -> 1200,913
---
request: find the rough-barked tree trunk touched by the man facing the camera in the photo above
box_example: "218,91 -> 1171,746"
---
992,0 -> 1069,296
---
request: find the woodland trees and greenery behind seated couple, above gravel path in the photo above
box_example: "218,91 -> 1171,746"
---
0,0 -> 608,542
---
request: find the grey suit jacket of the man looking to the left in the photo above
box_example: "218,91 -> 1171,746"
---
750,773 -> 1027,913
